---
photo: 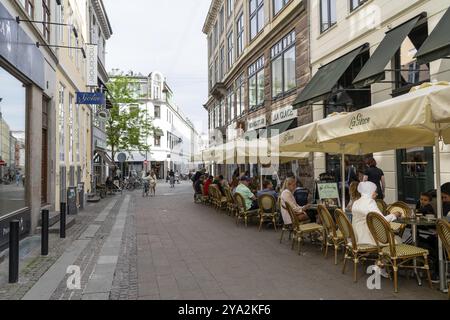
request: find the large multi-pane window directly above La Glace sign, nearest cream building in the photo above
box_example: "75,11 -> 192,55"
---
270,31 -> 297,98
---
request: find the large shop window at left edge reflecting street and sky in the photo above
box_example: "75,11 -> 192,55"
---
0,67 -> 27,218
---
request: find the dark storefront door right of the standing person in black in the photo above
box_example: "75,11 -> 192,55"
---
397,148 -> 434,203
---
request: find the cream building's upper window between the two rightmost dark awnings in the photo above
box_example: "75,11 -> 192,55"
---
394,23 -> 430,95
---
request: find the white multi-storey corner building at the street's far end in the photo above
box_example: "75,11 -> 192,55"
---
115,71 -> 199,179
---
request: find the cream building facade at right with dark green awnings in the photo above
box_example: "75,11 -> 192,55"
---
304,0 -> 450,203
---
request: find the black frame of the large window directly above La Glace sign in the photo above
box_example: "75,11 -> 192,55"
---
270,30 -> 297,100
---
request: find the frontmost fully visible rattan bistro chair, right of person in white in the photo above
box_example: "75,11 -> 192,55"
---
367,212 -> 433,293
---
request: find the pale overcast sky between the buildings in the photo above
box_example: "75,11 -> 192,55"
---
104,0 -> 211,132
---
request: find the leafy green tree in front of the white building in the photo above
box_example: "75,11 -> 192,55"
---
106,73 -> 154,165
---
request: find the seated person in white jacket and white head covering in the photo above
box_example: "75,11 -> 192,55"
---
352,182 -> 400,246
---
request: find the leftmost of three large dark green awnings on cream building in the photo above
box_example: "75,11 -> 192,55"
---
293,43 -> 368,109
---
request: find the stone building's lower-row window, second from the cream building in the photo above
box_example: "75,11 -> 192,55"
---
248,57 -> 264,110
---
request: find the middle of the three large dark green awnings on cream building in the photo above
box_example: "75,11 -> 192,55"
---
353,15 -> 422,88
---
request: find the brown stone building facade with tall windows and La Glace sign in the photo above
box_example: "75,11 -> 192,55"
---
203,0 -> 313,187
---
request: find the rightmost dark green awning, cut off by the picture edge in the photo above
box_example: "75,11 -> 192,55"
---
416,8 -> 450,64
